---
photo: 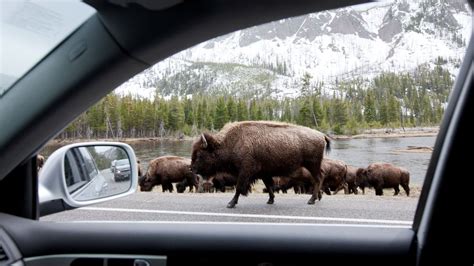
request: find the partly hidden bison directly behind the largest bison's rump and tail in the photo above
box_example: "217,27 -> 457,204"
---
321,158 -> 347,195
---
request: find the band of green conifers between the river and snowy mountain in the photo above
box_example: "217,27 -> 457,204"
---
58,58 -> 453,139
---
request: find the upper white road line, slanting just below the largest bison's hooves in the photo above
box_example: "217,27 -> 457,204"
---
81,207 -> 413,225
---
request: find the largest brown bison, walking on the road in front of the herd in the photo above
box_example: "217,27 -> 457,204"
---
192,121 -> 330,208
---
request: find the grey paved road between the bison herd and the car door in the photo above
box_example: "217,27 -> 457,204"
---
42,191 -> 418,227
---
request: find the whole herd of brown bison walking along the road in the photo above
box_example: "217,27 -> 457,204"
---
139,121 -> 410,208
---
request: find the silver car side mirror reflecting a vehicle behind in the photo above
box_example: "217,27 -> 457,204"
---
38,142 -> 138,216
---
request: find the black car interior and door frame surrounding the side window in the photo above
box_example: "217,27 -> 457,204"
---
0,0 -> 474,265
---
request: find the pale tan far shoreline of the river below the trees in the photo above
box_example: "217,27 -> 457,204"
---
46,127 -> 439,146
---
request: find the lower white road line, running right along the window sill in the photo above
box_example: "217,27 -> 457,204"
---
63,220 -> 411,229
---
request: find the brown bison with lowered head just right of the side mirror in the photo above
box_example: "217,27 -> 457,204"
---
139,156 -> 198,192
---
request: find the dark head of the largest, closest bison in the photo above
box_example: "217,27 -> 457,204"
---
191,133 -> 219,176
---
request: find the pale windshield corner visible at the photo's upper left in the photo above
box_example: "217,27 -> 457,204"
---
0,0 -> 95,93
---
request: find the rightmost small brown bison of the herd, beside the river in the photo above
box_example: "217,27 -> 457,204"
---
357,163 -> 410,196
